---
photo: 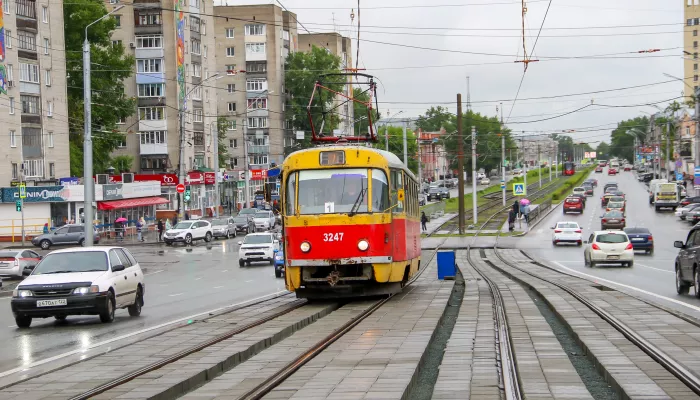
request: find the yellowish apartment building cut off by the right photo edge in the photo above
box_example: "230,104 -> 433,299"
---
682,0 -> 700,97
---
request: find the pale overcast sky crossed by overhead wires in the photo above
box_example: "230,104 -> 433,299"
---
222,0 -> 684,147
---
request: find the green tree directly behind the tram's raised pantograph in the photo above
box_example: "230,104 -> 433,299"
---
285,46 -> 343,151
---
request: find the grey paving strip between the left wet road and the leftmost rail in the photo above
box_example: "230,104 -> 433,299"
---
0,296 -> 308,400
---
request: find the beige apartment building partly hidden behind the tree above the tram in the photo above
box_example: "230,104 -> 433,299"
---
299,32 -> 352,136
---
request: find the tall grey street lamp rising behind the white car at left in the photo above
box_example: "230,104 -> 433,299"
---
83,5 -> 124,247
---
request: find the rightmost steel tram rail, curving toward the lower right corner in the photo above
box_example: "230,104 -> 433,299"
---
493,245 -> 700,395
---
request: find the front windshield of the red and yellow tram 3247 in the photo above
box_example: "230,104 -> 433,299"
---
297,168 -> 389,215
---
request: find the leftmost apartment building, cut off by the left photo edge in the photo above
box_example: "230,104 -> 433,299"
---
0,0 -> 70,186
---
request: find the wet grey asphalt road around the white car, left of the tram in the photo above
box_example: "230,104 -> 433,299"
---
0,236 -> 284,378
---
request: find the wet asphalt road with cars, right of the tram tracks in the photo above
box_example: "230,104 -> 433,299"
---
503,168 -> 700,316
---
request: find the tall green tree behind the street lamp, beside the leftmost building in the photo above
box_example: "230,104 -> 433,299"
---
63,0 -> 136,176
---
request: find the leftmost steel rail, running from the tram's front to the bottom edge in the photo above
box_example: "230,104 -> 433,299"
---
70,300 -> 307,400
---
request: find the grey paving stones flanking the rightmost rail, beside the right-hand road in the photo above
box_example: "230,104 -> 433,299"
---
486,250 -> 700,399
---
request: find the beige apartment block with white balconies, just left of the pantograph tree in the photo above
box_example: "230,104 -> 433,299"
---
214,4 -> 297,204
